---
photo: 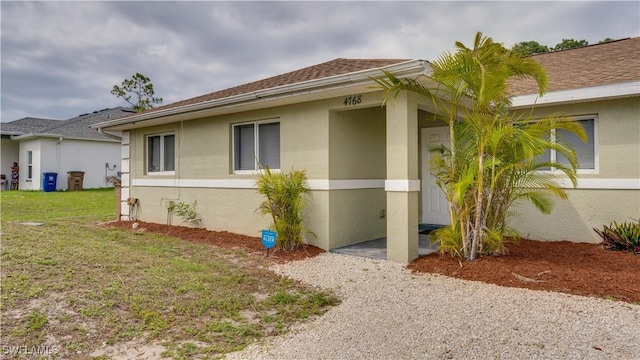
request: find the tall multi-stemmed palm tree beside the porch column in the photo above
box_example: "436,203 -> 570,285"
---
375,32 -> 586,260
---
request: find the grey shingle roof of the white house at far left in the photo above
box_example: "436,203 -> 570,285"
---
2,107 -> 133,140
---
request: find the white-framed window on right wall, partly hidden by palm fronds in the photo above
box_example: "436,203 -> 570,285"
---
543,116 -> 598,171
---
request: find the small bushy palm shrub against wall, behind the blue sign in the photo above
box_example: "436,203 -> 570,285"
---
256,168 -> 309,250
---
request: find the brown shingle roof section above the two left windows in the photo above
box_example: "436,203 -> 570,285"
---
146,58 -> 409,112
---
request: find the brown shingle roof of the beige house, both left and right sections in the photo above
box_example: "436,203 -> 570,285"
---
100,37 -> 640,127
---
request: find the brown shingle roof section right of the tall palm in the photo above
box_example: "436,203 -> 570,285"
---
509,37 -> 640,96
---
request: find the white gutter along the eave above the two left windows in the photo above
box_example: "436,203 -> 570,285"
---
91,60 -> 431,133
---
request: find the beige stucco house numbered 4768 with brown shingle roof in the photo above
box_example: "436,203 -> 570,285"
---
94,38 -> 640,263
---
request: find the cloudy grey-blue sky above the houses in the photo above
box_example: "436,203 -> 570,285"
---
0,1 -> 640,122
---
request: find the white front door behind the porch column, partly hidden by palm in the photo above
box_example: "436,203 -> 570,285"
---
421,126 -> 451,225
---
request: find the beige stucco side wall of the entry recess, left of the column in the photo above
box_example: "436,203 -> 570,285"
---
329,106 -> 386,248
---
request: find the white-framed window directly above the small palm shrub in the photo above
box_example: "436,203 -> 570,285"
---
233,121 -> 280,173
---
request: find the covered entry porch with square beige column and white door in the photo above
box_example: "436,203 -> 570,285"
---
325,93 -> 449,263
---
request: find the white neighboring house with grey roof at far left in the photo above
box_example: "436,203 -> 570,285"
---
0,107 -> 132,190
